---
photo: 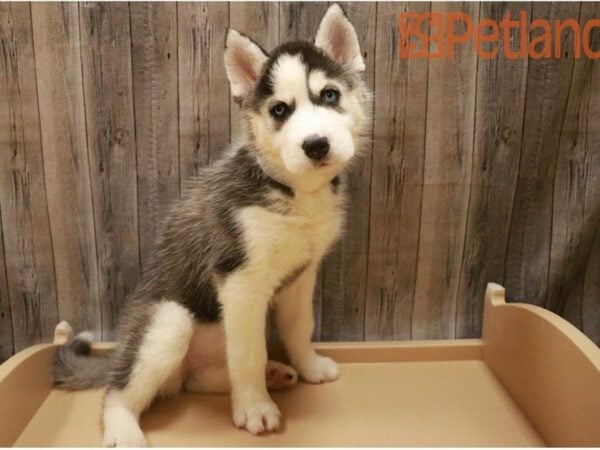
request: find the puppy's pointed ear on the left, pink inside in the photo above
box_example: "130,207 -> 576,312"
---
225,28 -> 268,98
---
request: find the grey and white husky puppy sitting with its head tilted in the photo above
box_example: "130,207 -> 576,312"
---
54,4 -> 370,446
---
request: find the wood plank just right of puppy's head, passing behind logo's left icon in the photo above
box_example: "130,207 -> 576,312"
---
365,2 -> 429,340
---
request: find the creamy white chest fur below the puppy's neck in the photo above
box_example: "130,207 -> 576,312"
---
239,186 -> 344,283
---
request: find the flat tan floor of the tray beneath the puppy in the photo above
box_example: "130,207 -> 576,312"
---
15,361 -> 543,446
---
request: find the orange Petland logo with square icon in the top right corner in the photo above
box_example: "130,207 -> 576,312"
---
398,11 -> 600,59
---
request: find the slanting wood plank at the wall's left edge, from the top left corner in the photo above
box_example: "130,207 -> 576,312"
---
0,3 -> 58,350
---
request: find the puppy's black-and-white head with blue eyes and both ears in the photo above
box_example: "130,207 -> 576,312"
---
225,4 -> 368,191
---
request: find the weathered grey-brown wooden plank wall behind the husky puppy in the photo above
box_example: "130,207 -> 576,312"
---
0,2 -> 600,359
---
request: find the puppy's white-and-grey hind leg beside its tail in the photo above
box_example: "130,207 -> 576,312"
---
103,301 -> 193,447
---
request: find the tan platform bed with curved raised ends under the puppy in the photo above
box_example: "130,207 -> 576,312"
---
0,284 -> 600,446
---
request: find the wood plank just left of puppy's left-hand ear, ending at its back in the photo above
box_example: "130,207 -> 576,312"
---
177,2 -> 230,183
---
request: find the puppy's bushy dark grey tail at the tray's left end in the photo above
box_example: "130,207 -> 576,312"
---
52,332 -> 109,390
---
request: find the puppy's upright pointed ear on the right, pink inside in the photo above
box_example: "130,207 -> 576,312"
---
315,3 -> 365,72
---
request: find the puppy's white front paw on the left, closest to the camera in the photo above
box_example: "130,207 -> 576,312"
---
233,396 -> 281,434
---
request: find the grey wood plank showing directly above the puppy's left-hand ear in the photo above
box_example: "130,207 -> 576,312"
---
230,2 -> 279,142
